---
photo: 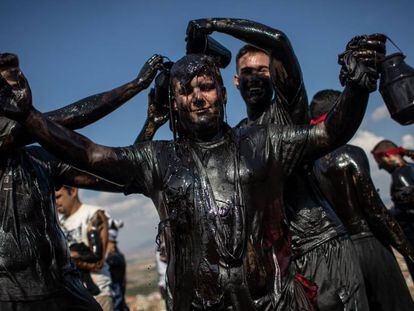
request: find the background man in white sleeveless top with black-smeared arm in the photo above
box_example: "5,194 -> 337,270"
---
55,186 -> 114,311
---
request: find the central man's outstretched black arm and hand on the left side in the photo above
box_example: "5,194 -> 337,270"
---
0,62 -> 160,185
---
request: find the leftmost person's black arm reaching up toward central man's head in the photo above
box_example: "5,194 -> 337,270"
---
0,55 -> 162,150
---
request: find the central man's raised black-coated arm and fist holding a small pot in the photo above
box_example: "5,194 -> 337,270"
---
304,34 -> 385,160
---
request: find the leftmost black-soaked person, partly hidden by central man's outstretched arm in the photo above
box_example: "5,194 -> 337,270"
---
0,53 -> 161,311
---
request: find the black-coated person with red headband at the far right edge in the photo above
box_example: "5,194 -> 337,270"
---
372,139 -> 414,279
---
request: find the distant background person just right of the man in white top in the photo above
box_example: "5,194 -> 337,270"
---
106,217 -> 129,311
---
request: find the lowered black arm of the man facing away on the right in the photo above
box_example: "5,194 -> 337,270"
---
351,148 -> 414,261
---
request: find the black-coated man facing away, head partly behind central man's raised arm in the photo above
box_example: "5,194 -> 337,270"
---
310,90 -> 414,311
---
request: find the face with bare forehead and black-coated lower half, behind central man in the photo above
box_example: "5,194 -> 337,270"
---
234,52 -> 273,109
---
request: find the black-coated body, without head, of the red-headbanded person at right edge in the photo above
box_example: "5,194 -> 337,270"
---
391,163 -> 414,277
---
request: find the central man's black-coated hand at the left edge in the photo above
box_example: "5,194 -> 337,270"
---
0,70 -> 32,121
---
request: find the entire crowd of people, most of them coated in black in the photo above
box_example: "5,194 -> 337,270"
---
0,18 -> 414,311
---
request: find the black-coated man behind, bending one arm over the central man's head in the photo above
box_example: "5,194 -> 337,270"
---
187,18 -> 385,310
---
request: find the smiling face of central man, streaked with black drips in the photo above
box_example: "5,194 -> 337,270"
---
174,74 -> 225,137
